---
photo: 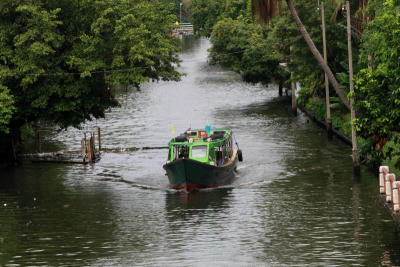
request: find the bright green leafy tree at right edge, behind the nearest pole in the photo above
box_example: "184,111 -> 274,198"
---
354,1 -> 400,139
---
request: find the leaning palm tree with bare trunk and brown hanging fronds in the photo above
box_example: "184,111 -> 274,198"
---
253,0 -> 350,109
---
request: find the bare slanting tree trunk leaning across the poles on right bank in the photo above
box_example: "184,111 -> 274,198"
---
286,0 -> 350,109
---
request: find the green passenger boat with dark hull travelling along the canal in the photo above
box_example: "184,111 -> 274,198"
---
163,126 -> 243,192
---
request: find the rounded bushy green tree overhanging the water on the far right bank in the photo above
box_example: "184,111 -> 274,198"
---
210,16 -> 288,85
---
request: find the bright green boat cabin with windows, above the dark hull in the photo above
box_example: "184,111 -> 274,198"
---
168,129 -> 233,166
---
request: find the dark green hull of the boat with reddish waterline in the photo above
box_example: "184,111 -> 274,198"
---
163,153 -> 238,191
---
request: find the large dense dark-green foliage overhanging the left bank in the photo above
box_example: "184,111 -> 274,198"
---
0,0 -> 180,134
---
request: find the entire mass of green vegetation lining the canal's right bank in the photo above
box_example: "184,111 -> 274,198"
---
191,0 -> 400,173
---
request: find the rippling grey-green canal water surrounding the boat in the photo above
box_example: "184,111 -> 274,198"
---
0,39 -> 400,266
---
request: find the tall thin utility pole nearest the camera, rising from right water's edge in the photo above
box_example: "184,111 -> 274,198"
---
346,1 -> 360,176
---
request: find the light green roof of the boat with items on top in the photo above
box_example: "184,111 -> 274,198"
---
169,128 -> 232,146
